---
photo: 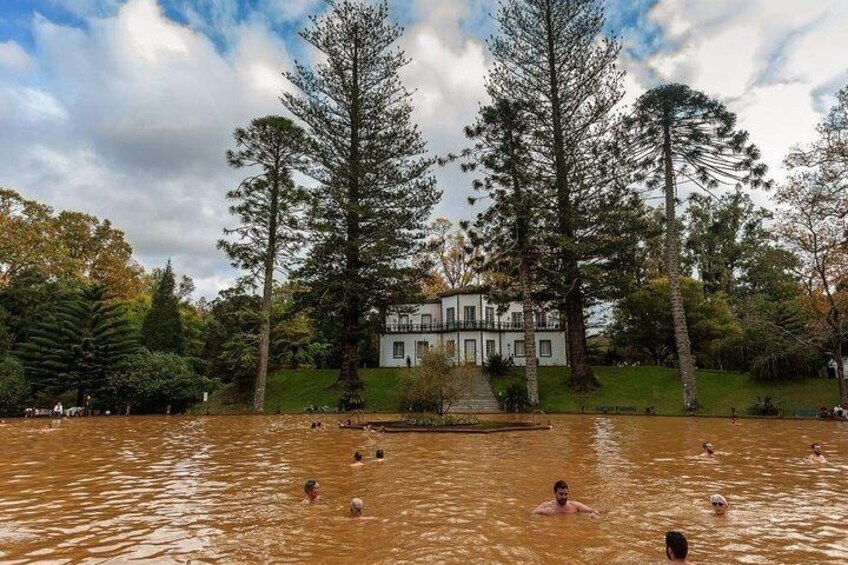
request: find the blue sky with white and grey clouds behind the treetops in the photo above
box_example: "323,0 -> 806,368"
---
0,0 -> 848,297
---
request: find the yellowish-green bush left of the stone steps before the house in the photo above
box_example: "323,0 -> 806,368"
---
401,345 -> 474,415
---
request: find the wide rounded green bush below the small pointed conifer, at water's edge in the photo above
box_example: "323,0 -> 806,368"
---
109,352 -> 213,414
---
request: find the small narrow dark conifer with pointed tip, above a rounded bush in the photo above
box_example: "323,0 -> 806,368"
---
141,261 -> 185,355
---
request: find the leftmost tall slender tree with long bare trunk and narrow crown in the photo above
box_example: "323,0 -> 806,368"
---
218,116 -> 307,412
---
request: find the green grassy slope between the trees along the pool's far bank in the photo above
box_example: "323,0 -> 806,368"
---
200,367 -> 839,416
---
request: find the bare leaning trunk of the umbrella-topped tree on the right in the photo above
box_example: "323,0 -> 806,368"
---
663,122 -> 700,410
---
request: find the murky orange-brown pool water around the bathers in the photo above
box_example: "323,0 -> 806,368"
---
0,416 -> 848,564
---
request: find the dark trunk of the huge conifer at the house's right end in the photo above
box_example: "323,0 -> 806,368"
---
545,5 -> 601,391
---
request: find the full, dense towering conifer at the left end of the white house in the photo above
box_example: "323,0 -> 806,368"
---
282,0 -> 440,409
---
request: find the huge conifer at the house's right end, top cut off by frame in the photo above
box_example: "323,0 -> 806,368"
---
488,0 -> 626,391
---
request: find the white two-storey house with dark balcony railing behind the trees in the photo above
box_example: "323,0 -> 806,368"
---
380,289 -> 567,367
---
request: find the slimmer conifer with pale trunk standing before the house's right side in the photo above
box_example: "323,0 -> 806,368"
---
463,100 -> 541,406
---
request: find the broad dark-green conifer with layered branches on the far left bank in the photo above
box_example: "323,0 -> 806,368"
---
17,284 -> 139,406
